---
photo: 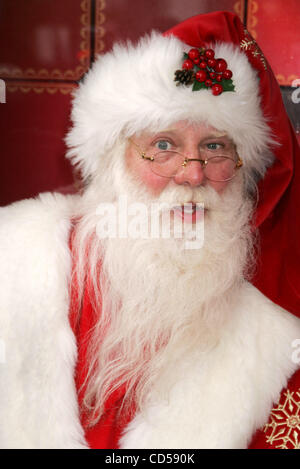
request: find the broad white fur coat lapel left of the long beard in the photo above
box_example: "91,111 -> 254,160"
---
0,194 -> 86,448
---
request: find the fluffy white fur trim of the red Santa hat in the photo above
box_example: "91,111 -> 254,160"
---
66,32 -> 272,179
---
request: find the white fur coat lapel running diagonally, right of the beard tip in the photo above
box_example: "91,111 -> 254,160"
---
120,284 -> 300,449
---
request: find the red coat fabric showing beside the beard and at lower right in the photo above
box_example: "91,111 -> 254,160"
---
71,278 -> 300,449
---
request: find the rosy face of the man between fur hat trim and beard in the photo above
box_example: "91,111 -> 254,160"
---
125,121 -> 236,197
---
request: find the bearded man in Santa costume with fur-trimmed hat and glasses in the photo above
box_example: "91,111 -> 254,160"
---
0,12 -> 300,449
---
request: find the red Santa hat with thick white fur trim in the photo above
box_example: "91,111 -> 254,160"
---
66,12 -> 300,314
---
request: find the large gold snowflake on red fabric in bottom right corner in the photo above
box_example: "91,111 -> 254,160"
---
264,388 -> 300,449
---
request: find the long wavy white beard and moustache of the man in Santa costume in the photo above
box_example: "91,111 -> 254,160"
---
73,141 -> 253,423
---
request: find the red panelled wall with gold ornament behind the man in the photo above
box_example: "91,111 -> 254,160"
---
0,0 -> 300,205
